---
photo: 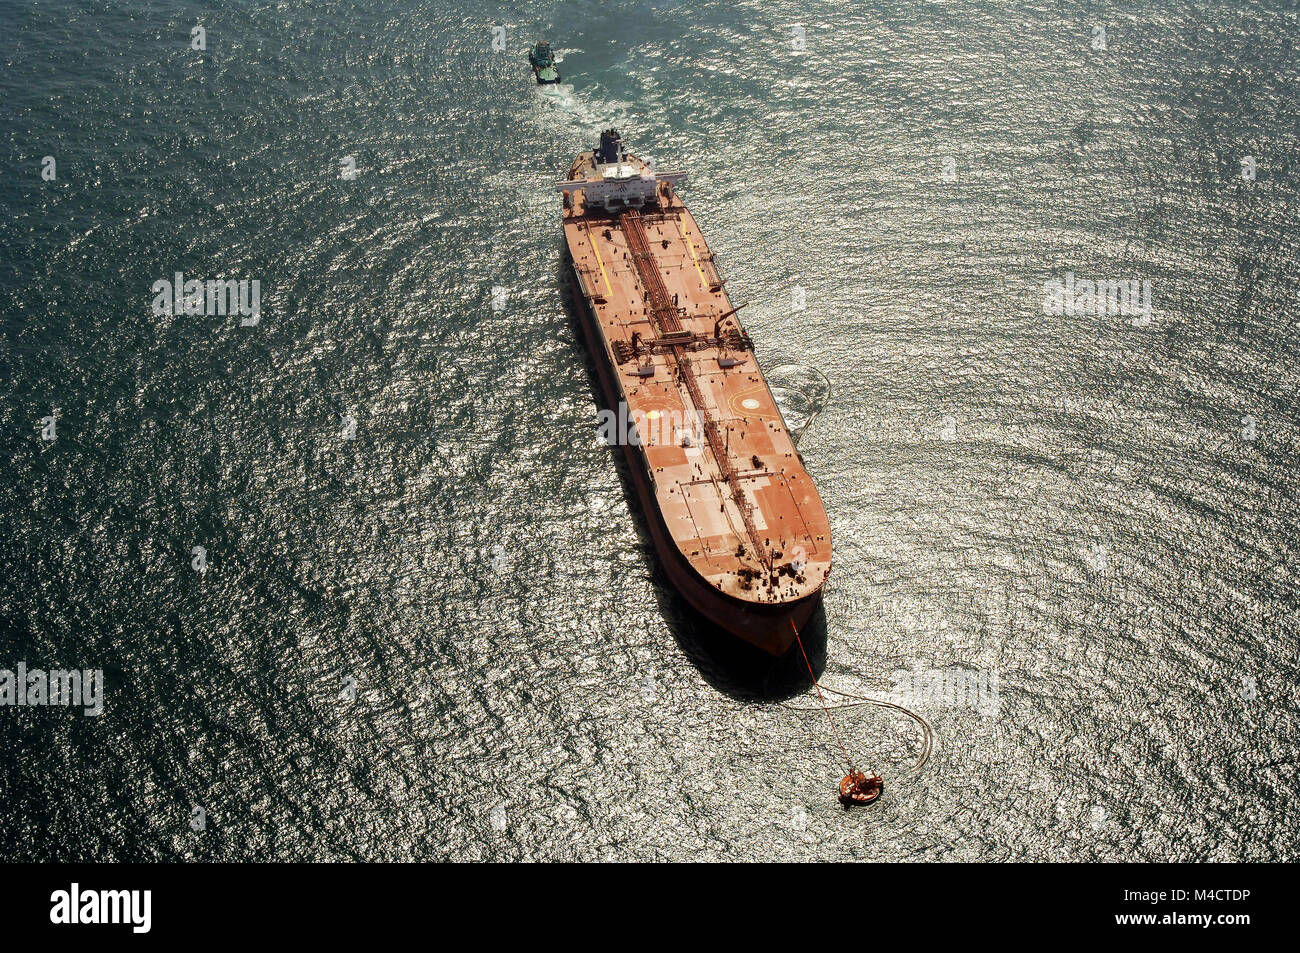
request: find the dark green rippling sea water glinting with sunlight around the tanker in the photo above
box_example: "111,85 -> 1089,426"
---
0,0 -> 1300,859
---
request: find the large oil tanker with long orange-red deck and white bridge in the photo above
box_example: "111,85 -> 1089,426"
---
556,129 -> 831,655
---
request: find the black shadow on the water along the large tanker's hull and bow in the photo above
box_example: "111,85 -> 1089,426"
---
556,256 -> 827,702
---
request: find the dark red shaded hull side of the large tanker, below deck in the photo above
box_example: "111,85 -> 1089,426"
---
564,263 -> 822,658
